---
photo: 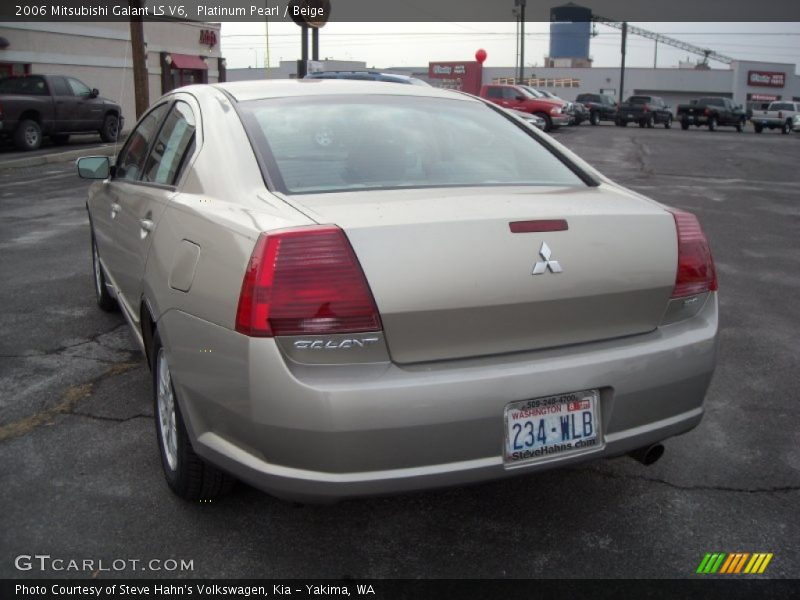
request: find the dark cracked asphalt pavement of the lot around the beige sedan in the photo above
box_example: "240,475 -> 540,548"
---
0,125 -> 800,578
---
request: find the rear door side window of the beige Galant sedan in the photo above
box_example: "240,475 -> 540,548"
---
142,102 -> 195,185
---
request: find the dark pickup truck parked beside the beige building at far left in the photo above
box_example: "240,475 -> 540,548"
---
0,75 -> 124,150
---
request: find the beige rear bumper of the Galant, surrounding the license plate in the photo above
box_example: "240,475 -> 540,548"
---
159,294 -> 717,501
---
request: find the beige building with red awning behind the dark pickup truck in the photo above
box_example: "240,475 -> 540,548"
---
0,21 -> 225,130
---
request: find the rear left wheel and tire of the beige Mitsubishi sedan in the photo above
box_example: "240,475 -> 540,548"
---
151,331 -> 236,502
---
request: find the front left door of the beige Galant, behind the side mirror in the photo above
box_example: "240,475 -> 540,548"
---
96,102 -> 169,312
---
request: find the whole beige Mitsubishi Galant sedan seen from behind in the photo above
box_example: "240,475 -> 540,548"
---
78,79 -> 717,501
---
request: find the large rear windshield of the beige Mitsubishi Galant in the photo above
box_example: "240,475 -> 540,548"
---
240,95 -> 586,193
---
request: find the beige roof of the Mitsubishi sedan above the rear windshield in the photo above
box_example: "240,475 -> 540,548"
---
212,78 -> 480,102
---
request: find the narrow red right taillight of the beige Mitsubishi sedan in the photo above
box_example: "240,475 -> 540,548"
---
670,209 -> 717,298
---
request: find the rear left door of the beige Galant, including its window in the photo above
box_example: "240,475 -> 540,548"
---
109,100 -> 196,320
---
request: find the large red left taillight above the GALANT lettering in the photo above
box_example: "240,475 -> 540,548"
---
236,225 -> 382,337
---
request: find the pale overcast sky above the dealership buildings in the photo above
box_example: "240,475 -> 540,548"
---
222,22 -> 800,69
